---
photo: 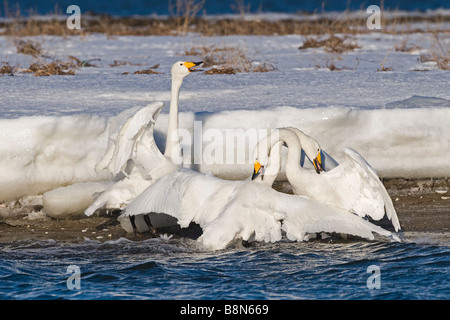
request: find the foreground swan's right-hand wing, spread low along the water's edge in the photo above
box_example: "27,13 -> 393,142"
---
199,182 -> 398,250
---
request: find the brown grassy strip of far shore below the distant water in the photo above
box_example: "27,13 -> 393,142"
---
0,10 -> 450,37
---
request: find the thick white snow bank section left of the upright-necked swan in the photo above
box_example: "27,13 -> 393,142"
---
0,115 -> 108,201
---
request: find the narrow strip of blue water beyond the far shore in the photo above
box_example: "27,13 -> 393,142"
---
0,0 -> 450,16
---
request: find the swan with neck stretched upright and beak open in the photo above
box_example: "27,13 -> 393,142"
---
84,61 -> 202,218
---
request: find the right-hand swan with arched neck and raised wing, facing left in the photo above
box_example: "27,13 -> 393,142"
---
255,127 -> 401,231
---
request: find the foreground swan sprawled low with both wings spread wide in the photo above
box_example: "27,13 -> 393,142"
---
118,138 -> 399,250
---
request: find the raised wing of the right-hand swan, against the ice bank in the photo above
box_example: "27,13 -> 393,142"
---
323,148 -> 400,230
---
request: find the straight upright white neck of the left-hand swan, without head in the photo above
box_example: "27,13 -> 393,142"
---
164,78 -> 183,158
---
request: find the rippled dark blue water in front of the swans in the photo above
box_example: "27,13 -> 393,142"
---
0,237 -> 450,300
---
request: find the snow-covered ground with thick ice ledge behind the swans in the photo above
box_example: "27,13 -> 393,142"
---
0,23 -> 450,208
